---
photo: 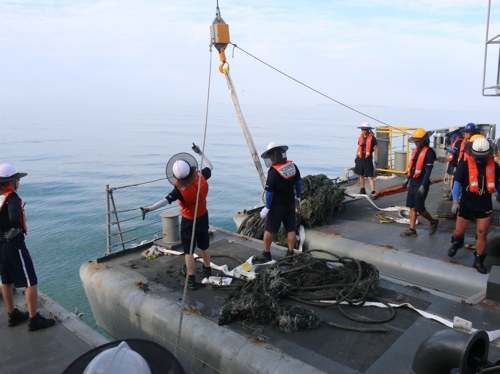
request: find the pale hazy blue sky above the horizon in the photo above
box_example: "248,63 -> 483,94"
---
0,0 -> 500,112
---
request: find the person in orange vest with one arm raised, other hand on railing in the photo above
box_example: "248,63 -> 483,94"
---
141,143 -> 214,290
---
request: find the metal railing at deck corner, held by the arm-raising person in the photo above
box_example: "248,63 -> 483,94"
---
105,178 -> 179,256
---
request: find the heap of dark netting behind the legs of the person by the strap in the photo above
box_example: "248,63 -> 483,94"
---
238,174 -> 344,248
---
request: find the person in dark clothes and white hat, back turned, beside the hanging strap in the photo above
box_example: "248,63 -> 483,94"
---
253,142 -> 302,262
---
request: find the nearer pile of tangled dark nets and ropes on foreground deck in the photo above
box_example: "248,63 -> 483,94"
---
219,250 -> 394,332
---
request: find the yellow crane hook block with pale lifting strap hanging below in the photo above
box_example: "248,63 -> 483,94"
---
210,1 -> 266,188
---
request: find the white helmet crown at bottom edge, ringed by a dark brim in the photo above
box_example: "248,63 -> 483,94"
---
83,342 -> 151,374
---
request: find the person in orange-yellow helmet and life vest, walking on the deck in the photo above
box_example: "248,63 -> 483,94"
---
400,128 -> 439,236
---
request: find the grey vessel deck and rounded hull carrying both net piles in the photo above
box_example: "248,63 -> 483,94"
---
80,167 -> 500,373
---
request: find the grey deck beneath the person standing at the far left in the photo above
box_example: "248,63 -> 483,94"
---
0,289 -> 107,374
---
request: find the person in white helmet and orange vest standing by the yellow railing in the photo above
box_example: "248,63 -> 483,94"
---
354,122 -> 378,195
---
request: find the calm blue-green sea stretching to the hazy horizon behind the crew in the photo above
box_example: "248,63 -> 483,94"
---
0,97 -> 500,327
